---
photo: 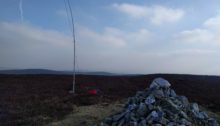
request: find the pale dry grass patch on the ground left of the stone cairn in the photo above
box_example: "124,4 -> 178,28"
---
47,101 -> 123,126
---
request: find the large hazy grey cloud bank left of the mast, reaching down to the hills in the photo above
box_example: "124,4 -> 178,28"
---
0,22 -> 72,70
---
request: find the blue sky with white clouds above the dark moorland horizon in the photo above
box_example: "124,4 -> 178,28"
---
0,0 -> 220,75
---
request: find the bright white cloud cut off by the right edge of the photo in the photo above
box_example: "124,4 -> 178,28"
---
176,15 -> 220,45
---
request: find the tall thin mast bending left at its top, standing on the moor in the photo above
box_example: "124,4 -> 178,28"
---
64,0 -> 76,94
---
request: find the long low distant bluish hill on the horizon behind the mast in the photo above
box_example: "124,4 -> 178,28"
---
0,69 -> 116,76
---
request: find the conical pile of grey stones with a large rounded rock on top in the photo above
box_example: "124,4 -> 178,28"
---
96,78 -> 219,126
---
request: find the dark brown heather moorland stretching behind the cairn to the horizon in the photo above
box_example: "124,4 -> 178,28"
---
0,74 -> 220,126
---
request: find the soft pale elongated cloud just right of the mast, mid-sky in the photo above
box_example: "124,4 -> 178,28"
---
79,27 -> 152,47
